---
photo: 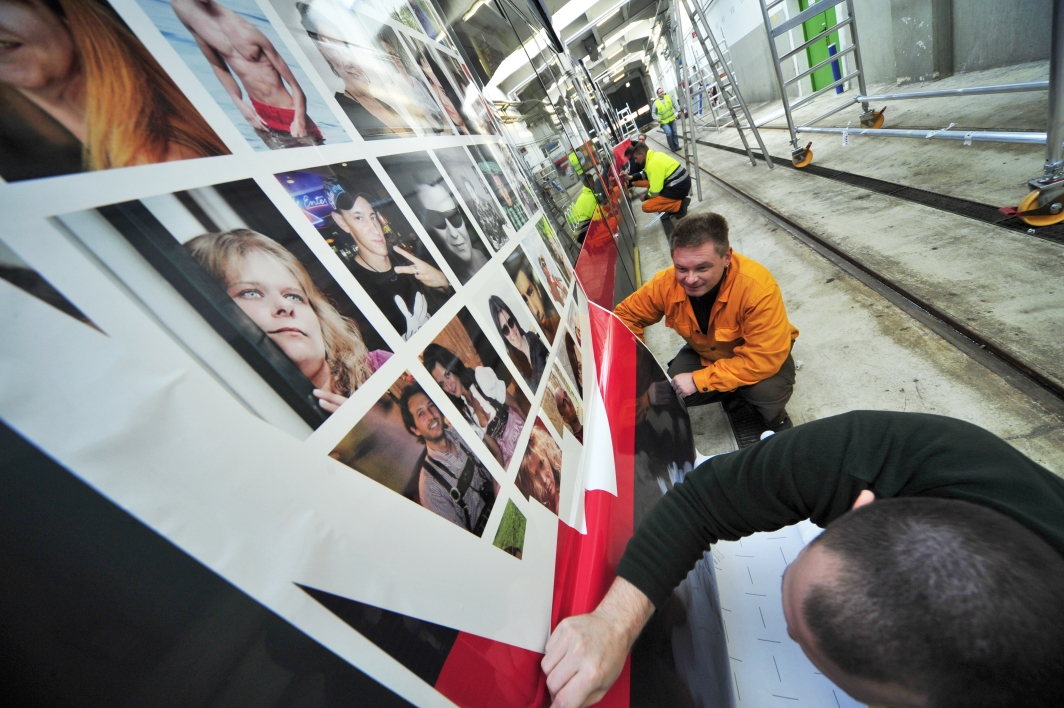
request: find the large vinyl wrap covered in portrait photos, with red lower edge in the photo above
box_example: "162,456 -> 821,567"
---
0,0 -> 727,708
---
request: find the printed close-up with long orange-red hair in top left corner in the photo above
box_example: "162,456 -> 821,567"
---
0,0 -> 229,181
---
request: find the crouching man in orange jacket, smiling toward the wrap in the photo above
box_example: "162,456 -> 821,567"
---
614,209 -> 798,431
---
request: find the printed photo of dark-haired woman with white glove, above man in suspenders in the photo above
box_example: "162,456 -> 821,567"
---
421,316 -> 529,468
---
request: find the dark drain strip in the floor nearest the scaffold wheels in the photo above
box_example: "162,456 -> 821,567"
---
680,136 -> 1064,244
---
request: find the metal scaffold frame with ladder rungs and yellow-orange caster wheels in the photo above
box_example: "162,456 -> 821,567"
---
757,0 -> 1064,226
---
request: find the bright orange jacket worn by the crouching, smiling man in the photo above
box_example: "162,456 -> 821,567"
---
614,252 -> 798,391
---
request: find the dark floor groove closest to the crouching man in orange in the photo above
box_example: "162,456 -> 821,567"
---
672,141 -> 1064,417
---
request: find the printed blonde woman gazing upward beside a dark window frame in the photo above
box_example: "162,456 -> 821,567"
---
185,229 -> 390,413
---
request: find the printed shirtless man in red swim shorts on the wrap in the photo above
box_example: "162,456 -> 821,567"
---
170,0 -> 325,150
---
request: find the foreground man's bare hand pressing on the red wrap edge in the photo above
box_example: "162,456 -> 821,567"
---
541,578 -> 654,708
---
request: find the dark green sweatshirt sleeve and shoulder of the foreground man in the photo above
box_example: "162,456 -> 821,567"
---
617,411 -> 1064,607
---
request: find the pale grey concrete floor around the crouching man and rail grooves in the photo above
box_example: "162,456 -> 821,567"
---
636,127 -> 1064,475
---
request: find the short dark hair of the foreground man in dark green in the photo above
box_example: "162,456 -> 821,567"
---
802,497 -> 1064,708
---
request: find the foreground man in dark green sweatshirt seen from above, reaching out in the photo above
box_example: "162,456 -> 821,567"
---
543,411 -> 1064,708
